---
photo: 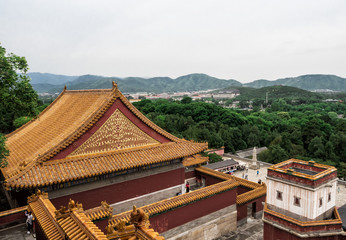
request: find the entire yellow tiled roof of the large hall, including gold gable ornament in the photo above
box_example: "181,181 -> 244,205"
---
1,85 -> 207,189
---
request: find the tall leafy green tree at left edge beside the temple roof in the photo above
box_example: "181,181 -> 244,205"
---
0,45 -> 38,133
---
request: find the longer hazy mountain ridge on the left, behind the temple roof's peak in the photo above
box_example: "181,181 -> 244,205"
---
32,74 -> 241,93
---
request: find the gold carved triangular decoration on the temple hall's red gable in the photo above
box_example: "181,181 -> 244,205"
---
70,109 -> 160,156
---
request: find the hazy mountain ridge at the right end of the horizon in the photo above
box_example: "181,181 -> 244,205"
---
244,74 -> 346,91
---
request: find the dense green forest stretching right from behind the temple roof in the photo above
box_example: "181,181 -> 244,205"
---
135,97 -> 346,178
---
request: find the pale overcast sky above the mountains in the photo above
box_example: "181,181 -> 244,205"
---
0,0 -> 346,82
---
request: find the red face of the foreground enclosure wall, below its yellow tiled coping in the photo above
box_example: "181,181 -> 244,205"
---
150,189 -> 236,233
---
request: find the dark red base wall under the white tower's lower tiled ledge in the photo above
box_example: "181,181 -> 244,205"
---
263,223 -> 344,240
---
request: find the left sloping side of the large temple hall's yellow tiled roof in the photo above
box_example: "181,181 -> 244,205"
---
1,90 -> 112,178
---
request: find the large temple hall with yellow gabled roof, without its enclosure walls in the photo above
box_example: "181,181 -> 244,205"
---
1,84 -> 208,209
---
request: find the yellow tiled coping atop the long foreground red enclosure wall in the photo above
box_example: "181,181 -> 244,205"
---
109,179 -> 239,227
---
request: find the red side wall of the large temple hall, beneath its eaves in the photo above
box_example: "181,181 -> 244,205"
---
51,168 -> 185,210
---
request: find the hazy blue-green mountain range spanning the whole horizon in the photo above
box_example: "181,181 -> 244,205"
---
28,72 -> 346,93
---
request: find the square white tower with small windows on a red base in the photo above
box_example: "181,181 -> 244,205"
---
263,159 -> 346,240
